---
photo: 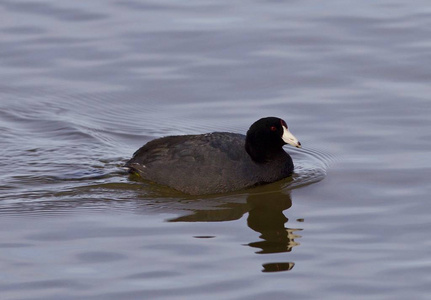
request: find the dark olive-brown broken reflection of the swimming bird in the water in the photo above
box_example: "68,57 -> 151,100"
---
170,190 -> 302,272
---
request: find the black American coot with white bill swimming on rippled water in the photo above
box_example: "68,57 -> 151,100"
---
125,117 -> 301,195
